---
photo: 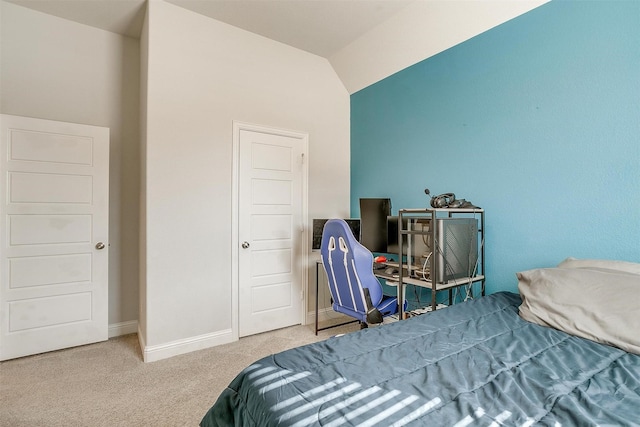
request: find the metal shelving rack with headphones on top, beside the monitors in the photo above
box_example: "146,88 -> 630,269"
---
397,208 -> 485,319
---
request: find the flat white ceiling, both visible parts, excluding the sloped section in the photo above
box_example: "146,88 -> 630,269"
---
7,0 -> 418,57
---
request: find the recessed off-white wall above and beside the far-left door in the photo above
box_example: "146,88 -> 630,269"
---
0,1 -> 139,334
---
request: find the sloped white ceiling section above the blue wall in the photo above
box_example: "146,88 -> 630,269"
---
329,0 -> 549,93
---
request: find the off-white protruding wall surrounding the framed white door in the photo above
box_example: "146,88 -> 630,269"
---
141,1 -> 349,360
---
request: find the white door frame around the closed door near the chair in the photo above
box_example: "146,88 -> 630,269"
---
231,120 -> 309,340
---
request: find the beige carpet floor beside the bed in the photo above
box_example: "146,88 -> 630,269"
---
0,323 -> 359,427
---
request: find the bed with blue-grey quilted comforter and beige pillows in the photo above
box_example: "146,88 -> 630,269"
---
201,259 -> 640,427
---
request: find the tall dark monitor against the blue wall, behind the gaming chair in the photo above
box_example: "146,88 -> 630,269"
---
360,198 -> 391,253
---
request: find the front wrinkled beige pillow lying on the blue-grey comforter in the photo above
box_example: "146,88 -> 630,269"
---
517,267 -> 640,354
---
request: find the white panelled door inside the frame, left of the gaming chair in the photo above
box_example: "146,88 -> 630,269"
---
238,125 -> 307,337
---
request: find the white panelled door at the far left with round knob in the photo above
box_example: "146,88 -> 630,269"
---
0,115 -> 109,360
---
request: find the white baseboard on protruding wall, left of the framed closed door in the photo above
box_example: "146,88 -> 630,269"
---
138,329 -> 237,362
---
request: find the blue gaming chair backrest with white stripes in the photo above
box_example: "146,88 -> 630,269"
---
320,219 -> 382,314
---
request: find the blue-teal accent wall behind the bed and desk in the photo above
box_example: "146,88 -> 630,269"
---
351,0 -> 640,293
